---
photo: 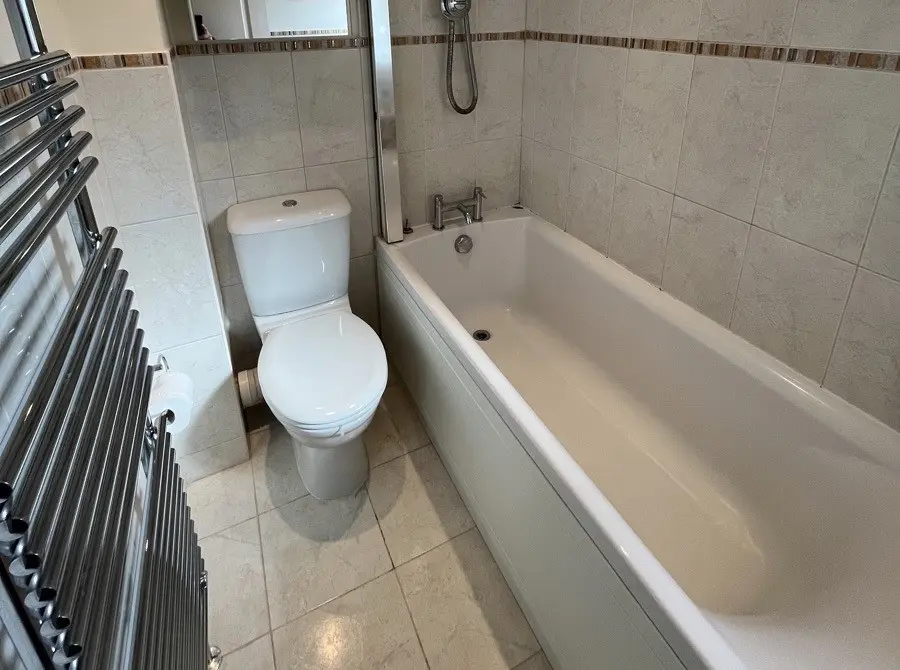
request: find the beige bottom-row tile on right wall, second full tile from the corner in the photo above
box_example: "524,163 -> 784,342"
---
566,158 -> 616,254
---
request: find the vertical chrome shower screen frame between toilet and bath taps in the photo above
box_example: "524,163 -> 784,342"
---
368,0 -> 406,243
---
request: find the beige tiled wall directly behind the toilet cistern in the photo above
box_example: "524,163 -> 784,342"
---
175,48 -> 380,370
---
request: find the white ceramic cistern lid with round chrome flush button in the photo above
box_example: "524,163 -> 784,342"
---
227,188 -> 351,235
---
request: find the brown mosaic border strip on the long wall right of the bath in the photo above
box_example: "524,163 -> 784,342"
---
525,30 -> 900,72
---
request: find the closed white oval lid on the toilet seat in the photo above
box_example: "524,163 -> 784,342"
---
257,312 -> 387,427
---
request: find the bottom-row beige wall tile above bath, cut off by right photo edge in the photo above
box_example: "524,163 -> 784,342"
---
825,270 -> 900,430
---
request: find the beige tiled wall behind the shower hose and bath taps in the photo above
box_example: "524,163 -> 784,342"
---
390,0 -> 525,226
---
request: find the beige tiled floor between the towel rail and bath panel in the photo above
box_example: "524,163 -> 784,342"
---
188,378 -> 550,670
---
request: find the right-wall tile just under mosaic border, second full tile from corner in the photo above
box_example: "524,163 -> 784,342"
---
570,45 -> 628,170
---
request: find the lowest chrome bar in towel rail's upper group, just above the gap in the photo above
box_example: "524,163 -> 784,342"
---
0,157 -> 98,297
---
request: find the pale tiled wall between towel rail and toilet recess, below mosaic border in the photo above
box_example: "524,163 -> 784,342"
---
77,65 -> 248,481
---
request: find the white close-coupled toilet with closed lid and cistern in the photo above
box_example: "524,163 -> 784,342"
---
228,189 -> 387,500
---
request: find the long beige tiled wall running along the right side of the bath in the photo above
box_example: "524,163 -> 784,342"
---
522,0 -> 900,428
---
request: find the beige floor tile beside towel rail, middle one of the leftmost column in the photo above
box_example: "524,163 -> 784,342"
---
200,518 -> 269,654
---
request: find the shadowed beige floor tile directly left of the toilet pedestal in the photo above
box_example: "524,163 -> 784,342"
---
250,423 -> 309,514
